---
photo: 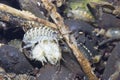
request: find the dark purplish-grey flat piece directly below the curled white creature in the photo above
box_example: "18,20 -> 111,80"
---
37,53 -> 86,80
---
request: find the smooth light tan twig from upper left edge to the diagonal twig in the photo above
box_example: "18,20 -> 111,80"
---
0,3 -> 57,28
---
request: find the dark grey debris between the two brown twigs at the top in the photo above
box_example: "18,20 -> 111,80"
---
17,0 -> 46,19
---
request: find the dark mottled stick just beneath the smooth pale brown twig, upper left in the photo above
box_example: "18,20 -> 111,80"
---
0,11 -> 55,32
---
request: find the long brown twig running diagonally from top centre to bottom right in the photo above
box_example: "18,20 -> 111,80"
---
41,0 -> 98,80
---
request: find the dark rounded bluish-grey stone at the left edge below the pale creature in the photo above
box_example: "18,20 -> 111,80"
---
0,43 -> 33,74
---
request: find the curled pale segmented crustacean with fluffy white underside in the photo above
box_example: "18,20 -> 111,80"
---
23,26 -> 62,65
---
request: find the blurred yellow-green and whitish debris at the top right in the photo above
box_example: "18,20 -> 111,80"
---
65,0 -> 105,22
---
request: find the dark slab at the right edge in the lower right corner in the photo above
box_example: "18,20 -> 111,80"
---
102,42 -> 120,80
